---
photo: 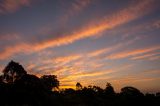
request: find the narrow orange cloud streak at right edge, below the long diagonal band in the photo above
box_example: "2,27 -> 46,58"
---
107,46 -> 160,59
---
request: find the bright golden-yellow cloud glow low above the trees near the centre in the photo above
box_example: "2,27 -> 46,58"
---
60,70 -> 114,88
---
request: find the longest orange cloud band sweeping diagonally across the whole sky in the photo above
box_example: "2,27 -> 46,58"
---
0,0 -> 156,60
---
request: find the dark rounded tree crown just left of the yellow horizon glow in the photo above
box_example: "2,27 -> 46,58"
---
40,75 -> 59,90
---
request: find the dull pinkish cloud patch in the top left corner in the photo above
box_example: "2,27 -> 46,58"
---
0,0 -> 31,14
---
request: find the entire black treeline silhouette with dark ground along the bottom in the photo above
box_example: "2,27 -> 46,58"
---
0,61 -> 160,106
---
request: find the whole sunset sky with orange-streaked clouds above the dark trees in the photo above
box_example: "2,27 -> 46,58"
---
0,0 -> 160,92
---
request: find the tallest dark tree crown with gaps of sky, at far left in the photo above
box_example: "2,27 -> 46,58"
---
3,61 -> 27,83
